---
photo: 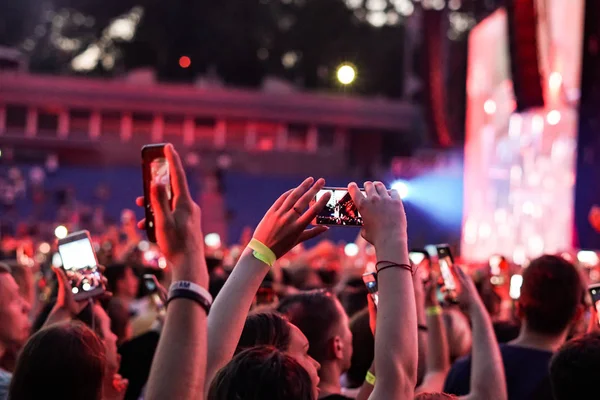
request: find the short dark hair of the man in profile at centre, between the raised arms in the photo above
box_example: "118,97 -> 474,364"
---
277,290 -> 341,364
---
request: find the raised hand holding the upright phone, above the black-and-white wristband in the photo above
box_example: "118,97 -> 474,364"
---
136,144 -> 207,281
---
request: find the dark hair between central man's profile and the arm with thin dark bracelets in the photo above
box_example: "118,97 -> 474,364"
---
346,309 -> 375,388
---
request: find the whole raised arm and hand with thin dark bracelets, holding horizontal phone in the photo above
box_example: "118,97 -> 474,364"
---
348,182 -> 417,399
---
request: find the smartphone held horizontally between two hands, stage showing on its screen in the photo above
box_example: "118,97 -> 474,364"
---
315,188 -> 364,226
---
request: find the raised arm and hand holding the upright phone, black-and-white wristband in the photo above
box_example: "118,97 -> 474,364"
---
138,145 -> 208,400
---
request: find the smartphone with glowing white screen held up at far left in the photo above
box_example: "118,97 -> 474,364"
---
58,231 -> 105,301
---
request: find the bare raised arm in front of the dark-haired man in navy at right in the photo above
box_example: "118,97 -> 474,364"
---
455,268 -> 508,400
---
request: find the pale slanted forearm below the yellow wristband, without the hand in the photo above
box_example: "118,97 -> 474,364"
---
206,249 -> 270,382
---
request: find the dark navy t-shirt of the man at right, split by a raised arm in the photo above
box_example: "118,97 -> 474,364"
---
444,344 -> 552,400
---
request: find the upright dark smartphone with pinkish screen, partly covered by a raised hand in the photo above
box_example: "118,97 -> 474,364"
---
142,143 -> 173,243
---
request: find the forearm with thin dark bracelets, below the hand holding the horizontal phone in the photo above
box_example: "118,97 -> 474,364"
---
374,241 -> 418,398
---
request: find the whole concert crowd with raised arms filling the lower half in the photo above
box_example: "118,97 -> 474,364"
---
0,145 -> 600,400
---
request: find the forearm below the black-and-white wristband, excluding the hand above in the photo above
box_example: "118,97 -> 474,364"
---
145,298 -> 207,400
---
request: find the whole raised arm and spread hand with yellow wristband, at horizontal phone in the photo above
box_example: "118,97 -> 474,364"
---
205,178 -> 329,390
